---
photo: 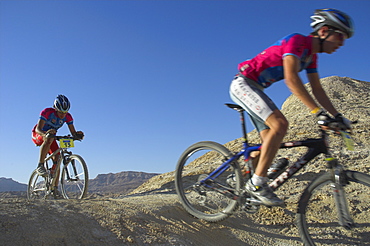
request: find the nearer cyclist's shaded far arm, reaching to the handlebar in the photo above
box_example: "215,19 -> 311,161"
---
307,73 -> 338,115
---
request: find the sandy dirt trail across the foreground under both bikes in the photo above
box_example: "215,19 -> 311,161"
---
0,192 -> 301,246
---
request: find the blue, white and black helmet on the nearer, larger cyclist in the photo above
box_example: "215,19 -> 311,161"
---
311,9 -> 355,38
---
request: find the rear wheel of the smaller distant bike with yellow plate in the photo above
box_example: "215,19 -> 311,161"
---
27,170 -> 47,200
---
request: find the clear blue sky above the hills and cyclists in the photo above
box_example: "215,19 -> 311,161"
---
0,0 -> 370,183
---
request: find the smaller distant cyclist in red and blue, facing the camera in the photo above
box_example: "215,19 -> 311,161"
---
32,95 -> 84,189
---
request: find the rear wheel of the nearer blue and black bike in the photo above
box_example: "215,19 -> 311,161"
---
175,142 -> 242,222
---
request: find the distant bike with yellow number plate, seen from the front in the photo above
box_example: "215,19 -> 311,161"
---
27,136 -> 89,200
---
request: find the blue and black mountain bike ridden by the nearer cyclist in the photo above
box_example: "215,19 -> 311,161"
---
175,104 -> 370,245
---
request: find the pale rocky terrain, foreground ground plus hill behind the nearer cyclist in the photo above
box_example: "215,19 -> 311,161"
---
0,76 -> 370,246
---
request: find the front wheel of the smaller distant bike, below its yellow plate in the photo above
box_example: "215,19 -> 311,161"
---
61,155 -> 89,199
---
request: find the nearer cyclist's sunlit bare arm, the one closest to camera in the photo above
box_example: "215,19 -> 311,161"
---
283,55 -> 318,110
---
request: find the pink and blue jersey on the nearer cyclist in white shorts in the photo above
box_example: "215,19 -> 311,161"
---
238,33 -> 317,88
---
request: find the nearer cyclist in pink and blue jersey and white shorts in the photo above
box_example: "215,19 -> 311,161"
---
230,9 -> 354,206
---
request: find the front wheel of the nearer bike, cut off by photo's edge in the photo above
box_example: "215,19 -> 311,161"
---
297,171 -> 370,246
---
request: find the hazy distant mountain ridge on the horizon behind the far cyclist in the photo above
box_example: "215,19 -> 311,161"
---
0,171 -> 158,194
